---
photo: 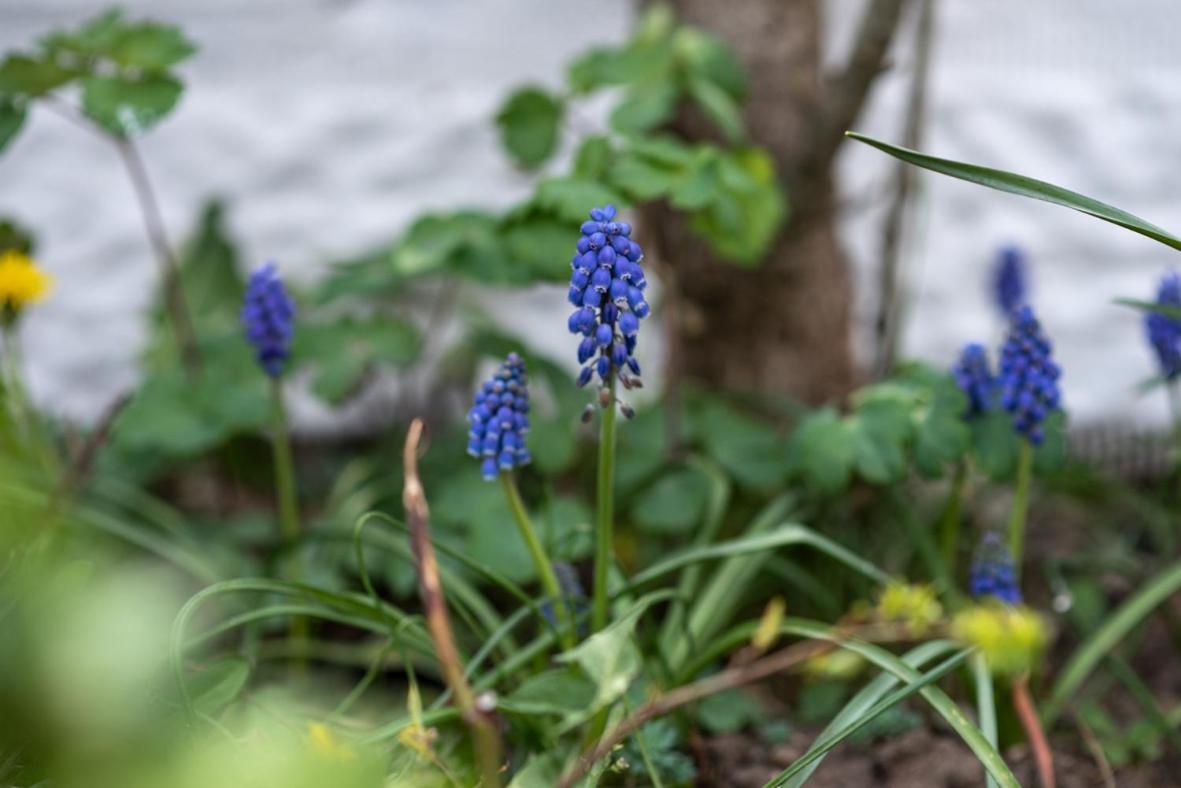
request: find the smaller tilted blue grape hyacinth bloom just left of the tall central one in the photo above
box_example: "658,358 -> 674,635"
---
468,353 -> 531,481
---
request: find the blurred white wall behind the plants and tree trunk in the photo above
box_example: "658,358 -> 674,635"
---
0,0 -> 1181,424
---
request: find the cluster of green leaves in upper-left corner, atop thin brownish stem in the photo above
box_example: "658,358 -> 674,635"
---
0,9 -> 196,150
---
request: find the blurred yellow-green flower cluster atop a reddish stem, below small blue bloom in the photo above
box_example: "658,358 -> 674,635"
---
952,601 -> 1049,676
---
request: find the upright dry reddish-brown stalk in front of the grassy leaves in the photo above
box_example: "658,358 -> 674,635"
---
402,418 -> 501,787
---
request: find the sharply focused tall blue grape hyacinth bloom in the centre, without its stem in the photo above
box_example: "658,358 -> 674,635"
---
567,206 -> 651,386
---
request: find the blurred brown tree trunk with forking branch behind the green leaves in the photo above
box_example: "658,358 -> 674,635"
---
645,0 -> 905,404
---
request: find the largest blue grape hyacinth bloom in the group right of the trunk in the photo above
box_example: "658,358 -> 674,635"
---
1000,306 -> 1062,445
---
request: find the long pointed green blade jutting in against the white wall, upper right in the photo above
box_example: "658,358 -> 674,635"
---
846,131 -> 1181,249
